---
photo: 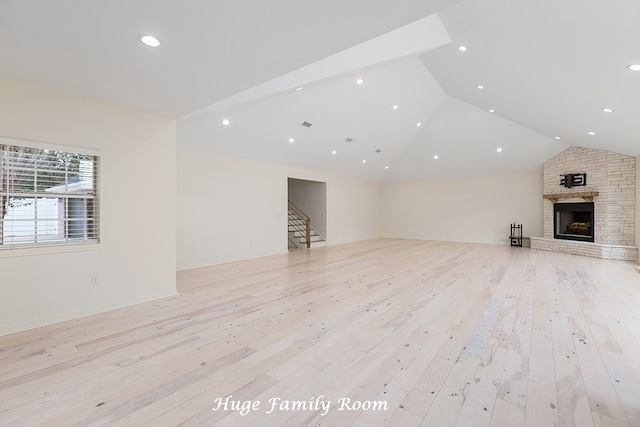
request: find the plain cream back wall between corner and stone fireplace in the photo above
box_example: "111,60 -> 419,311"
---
382,171 -> 543,245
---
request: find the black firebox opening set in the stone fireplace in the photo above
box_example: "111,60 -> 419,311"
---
553,202 -> 594,242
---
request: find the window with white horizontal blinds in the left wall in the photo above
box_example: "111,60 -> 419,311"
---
0,138 -> 100,251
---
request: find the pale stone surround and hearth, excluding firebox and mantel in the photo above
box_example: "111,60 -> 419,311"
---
531,147 -> 638,260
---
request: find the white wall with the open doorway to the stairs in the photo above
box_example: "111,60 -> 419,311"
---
177,147 -> 380,269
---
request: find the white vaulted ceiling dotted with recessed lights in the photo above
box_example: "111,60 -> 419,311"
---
0,0 -> 640,181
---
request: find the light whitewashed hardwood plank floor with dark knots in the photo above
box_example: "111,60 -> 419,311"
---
0,239 -> 640,427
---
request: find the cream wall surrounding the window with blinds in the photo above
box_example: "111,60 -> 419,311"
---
0,76 -> 176,335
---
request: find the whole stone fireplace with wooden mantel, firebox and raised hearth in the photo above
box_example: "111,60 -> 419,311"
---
531,147 -> 638,261
